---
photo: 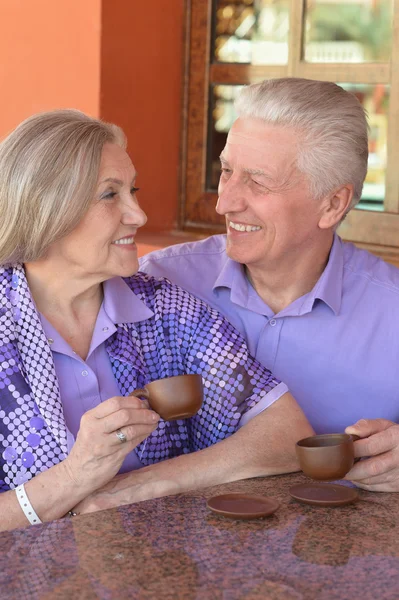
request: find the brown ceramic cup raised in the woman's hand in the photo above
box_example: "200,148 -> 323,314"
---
130,374 -> 204,421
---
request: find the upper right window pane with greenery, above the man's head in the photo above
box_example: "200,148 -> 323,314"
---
304,0 -> 393,63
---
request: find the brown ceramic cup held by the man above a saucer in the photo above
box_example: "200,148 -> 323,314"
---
295,433 -> 358,481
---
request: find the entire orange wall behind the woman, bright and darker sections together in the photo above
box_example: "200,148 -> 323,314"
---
0,0 -> 185,231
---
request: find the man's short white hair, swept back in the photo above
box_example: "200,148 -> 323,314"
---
235,77 -> 368,208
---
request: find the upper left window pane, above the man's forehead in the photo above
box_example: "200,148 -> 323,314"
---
214,0 -> 290,65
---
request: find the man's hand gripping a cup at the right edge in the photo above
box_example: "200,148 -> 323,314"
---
345,419 -> 399,492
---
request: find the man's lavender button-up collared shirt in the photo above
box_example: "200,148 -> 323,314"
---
140,235 -> 399,433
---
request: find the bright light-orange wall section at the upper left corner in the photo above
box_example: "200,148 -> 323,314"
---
0,0 -> 101,137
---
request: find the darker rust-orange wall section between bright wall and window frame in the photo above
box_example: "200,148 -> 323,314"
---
100,0 -> 184,231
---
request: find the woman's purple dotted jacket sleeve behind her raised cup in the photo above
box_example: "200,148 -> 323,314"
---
131,279 -> 287,464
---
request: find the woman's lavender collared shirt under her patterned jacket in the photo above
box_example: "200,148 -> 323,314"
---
40,277 -> 153,473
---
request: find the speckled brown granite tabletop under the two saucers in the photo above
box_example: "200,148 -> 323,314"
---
0,474 -> 399,600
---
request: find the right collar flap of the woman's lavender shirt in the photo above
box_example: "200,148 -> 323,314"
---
103,277 -> 154,324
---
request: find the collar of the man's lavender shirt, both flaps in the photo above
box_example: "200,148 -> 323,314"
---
213,234 -> 344,315
